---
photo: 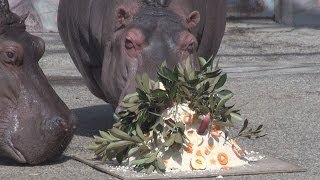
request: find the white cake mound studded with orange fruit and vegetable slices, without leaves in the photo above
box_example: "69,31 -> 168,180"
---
162,104 -> 248,171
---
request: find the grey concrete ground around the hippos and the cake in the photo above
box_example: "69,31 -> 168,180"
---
0,20 -> 320,179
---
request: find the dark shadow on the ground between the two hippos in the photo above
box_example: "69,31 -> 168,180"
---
72,104 -> 113,137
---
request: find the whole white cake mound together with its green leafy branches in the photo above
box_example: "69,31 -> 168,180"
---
88,57 -> 265,173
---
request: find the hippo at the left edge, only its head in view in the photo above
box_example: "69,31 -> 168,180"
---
0,0 -> 76,165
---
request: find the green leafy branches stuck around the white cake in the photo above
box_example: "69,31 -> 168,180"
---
88,57 -> 264,173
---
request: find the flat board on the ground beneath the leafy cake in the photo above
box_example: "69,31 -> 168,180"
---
73,155 -> 306,180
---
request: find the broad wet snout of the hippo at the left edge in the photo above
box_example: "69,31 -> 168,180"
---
7,113 -> 76,164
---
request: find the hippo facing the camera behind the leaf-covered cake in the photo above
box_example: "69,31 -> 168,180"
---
58,0 -> 226,108
